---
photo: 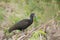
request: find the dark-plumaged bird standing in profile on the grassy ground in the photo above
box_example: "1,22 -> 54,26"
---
8,13 -> 34,32
